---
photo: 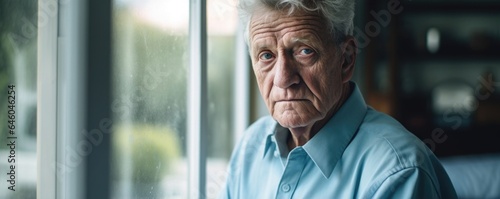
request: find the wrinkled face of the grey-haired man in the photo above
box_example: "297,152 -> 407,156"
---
249,10 -> 345,128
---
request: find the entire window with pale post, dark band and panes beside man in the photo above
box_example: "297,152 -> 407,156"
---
29,0 -> 249,198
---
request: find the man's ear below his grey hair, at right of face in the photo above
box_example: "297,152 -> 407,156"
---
341,35 -> 357,83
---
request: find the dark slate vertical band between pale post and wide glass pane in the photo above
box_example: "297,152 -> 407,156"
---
85,0 -> 112,199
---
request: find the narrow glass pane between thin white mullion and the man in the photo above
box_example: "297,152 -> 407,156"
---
207,0 -> 238,198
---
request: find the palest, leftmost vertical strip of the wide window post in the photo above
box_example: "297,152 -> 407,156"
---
36,0 -> 58,198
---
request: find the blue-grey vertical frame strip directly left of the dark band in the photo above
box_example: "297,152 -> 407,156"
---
56,1 -> 86,199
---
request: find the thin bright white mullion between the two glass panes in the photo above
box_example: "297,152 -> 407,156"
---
187,0 -> 208,199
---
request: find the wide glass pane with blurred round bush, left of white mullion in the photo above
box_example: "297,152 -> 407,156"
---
111,0 -> 189,199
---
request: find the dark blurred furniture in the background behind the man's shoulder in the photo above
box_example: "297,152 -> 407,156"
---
364,0 -> 500,157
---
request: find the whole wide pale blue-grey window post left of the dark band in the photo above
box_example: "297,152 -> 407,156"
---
37,0 -> 86,199
